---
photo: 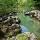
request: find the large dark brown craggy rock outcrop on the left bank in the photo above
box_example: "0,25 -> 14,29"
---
0,12 -> 21,38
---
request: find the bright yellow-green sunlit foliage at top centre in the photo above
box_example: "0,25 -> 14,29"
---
18,0 -> 34,11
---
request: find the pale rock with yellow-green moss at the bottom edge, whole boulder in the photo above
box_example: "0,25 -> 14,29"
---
16,32 -> 37,40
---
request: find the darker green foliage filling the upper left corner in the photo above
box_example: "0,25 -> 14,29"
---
0,0 -> 17,13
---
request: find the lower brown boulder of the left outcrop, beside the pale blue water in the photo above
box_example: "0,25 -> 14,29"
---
7,24 -> 21,35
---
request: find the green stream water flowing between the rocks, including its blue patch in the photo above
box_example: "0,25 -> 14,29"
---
18,13 -> 40,38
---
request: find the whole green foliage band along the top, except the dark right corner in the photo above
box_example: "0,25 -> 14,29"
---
0,0 -> 33,13
